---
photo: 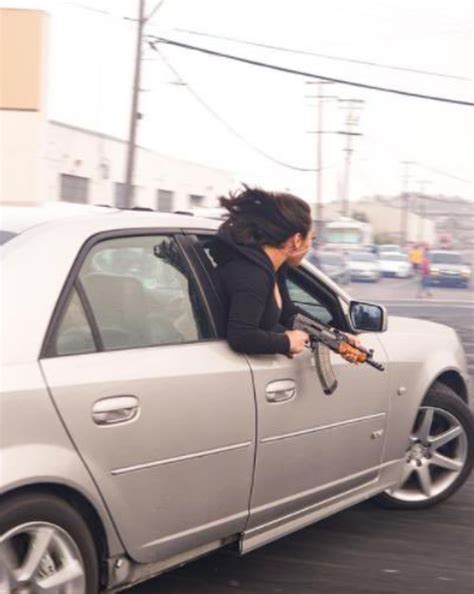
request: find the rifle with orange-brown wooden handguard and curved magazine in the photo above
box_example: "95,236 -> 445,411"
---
293,314 -> 384,394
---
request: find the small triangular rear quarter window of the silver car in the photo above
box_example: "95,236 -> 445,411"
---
53,290 -> 96,355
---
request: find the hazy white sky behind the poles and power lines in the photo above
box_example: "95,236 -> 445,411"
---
0,0 -> 474,201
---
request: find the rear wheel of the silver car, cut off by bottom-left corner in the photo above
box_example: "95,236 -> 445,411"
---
0,493 -> 99,594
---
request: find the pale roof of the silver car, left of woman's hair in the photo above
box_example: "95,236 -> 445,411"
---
0,202 -> 219,233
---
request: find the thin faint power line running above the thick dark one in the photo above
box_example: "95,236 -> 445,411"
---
174,29 -> 471,81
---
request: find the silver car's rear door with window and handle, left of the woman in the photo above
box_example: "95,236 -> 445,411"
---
40,231 -> 255,562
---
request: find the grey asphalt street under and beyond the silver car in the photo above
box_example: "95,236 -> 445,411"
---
126,279 -> 474,594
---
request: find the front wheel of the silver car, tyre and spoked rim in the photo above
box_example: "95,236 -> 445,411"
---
374,383 -> 474,509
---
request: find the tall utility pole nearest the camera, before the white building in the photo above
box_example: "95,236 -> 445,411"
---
123,0 -> 146,208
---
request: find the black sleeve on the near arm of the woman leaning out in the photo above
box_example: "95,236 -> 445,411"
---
221,261 -> 290,355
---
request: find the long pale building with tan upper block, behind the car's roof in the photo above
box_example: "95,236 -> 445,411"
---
0,9 -> 235,210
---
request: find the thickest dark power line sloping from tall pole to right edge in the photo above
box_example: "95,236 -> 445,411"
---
150,36 -> 474,107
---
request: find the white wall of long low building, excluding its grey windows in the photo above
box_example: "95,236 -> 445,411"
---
41,122 -> 235,210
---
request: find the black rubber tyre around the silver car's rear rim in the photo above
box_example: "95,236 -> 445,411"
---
0,493 -> 99,594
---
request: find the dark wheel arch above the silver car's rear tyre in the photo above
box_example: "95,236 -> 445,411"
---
0,482 -> 109,587
